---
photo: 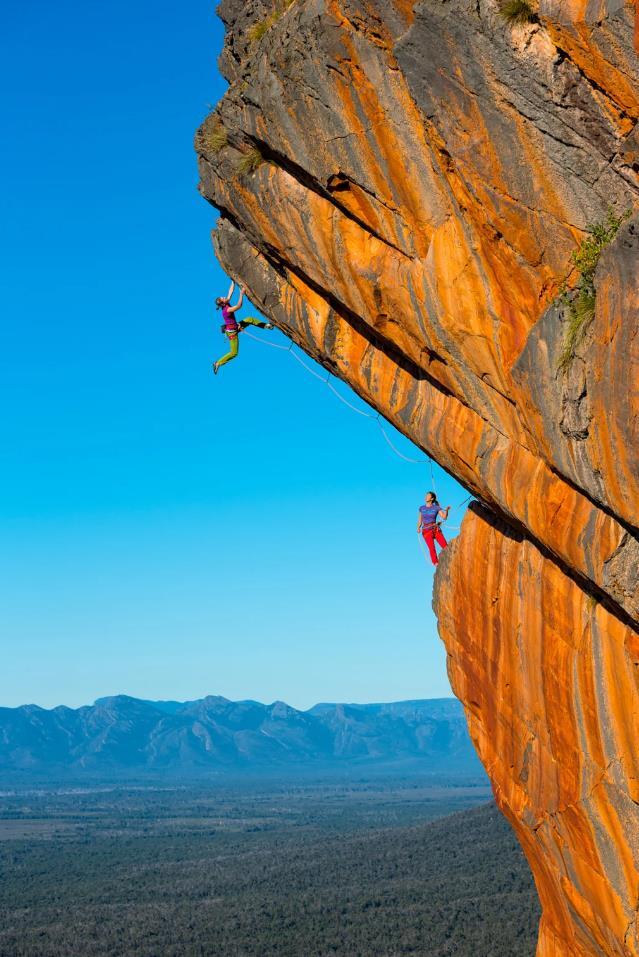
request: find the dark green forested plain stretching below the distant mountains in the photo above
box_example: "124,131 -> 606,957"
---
0,781 -> 539,957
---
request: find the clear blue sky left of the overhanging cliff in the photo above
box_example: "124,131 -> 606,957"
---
0,0 -> 464,707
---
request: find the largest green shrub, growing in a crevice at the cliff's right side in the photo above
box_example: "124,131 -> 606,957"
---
558,208 -> 632,372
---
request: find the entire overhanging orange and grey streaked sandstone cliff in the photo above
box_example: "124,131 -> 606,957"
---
196,0 -> 639,957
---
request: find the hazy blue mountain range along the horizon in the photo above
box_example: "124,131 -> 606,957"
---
0,695 -> 480,776
